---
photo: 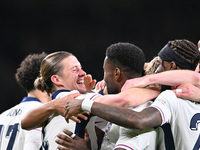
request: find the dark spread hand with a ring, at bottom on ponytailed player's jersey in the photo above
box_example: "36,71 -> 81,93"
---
55,129 -> 91,150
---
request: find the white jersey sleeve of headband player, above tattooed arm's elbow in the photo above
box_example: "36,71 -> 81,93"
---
150,90 -> 177,125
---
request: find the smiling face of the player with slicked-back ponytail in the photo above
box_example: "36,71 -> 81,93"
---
53,56 -> 87,93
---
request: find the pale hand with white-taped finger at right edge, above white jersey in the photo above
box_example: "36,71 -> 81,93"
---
173,83 -> 200,102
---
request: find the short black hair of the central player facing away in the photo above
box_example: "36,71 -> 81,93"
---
106,42 -> 145,78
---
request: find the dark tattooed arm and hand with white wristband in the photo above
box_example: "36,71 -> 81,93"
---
66,99 -> 162,130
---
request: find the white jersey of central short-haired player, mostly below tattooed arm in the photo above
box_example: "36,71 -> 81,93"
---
115,102 -> 160,150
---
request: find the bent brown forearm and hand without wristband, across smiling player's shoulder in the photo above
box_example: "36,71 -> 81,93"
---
21,93 -> 80,130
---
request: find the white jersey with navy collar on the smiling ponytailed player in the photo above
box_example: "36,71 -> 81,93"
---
42,90 -> 100,150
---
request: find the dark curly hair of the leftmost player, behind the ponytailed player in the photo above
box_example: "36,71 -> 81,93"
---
15,52 -> 47,92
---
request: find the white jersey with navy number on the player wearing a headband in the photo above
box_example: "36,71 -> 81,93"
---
151,90 -> 200,150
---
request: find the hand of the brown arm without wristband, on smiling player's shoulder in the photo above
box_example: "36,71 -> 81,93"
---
53,93 -> 80,116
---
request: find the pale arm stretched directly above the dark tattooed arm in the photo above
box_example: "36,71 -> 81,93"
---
94,88 -> 160,107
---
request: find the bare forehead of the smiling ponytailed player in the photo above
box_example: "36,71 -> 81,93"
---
61,56 -> 81,69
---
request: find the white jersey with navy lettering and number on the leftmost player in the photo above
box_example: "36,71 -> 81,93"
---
0,97 -> 42,150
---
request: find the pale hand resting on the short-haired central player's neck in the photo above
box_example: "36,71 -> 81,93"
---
121,76 -> 148,91
